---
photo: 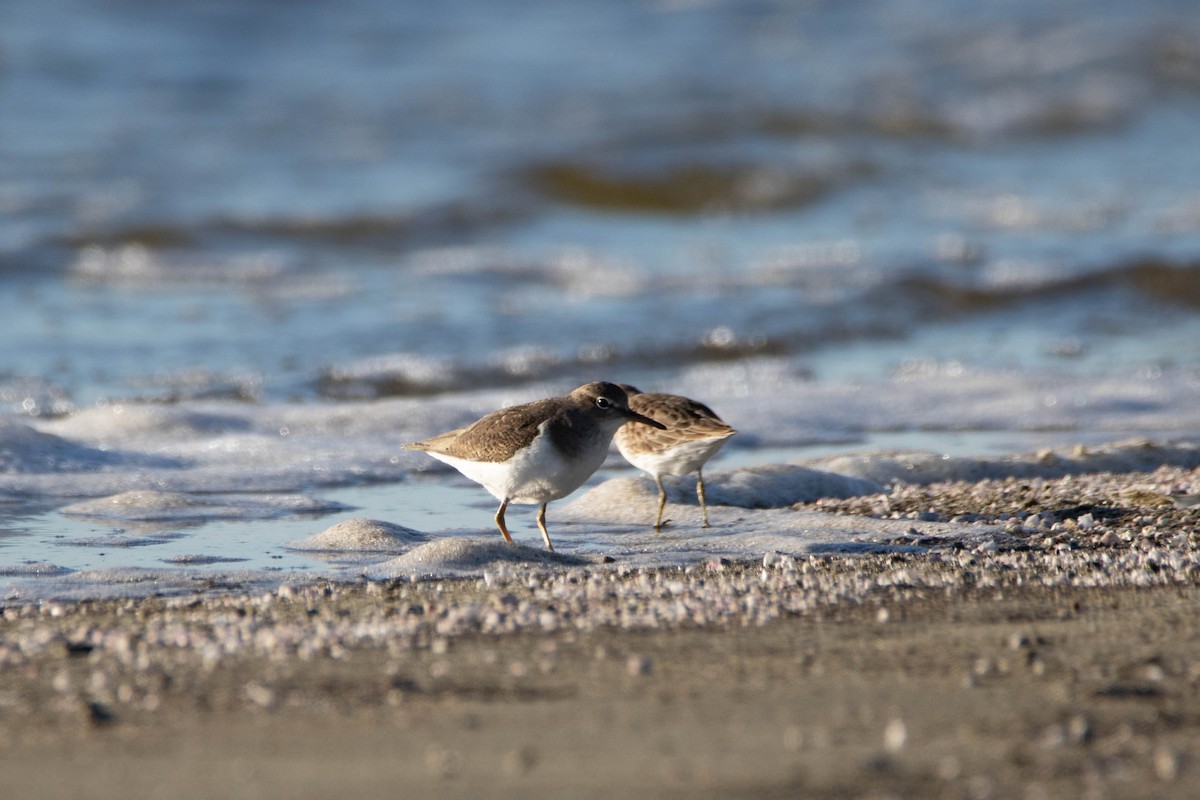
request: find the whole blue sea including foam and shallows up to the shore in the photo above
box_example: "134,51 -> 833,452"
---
0,0 -> 1200,599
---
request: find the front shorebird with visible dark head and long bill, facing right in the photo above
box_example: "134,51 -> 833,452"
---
404,381 -> 664,552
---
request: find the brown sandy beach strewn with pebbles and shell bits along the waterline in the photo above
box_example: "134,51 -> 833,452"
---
0,470 -> 1200,798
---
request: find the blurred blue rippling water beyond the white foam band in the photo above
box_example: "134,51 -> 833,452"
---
0,0 -> 1200,415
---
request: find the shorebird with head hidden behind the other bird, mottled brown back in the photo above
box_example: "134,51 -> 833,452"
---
617,384 -> 737,530
